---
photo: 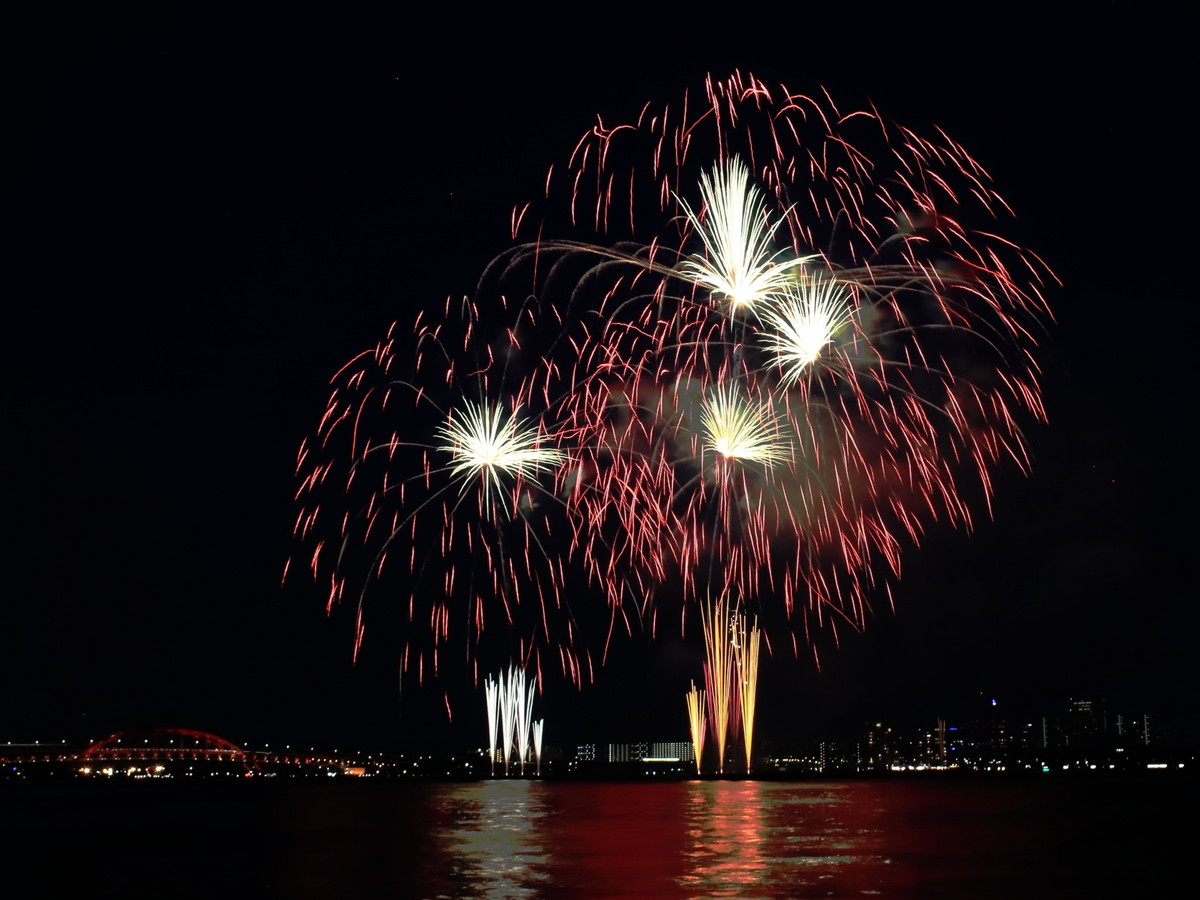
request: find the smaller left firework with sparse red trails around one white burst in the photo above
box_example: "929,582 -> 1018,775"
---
285,294 -> 590,680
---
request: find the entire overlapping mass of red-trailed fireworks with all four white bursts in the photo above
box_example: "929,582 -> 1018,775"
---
293,72 -> 1055,705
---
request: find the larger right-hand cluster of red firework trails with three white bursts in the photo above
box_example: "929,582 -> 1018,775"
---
510,73 -> 1054,657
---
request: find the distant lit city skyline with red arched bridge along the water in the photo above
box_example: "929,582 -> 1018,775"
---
9,700 -> 1200,780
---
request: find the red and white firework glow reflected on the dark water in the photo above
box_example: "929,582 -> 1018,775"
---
412,780 -> 907,898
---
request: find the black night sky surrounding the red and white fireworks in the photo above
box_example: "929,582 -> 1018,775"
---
9,5 -> 1198,746
